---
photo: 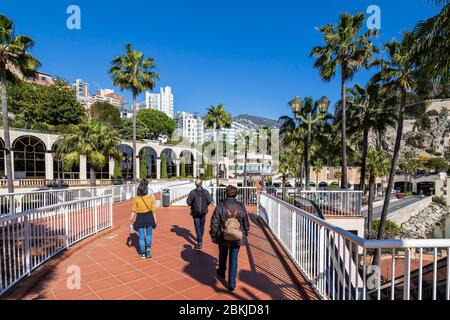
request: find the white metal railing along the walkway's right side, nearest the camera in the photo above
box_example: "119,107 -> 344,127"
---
258,193 -> 450,300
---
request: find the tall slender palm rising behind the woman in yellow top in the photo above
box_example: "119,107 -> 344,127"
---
109,44 -> 159,181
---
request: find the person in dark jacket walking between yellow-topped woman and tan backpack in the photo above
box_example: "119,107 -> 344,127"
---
187,180 -> 212,250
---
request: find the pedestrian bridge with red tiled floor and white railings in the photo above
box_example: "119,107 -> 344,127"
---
0,186 -> 450,300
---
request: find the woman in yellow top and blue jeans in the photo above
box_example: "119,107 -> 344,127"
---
130,184 -> 156,259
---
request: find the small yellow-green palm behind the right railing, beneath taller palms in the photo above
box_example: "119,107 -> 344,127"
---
367,148 -> 391,239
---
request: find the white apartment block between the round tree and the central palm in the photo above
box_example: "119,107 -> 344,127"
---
174,112 -> 204,145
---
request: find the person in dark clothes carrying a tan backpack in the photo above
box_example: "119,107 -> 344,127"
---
209,186 -> 250,292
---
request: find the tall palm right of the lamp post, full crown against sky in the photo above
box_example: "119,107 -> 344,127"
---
310,13 -> 378,189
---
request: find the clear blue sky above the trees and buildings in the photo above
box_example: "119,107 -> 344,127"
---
0,0 -> 438,119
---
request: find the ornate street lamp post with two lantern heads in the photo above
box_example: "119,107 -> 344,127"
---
289,97 -> 330,189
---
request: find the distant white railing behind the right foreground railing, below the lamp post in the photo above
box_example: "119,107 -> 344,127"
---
265,187 -> 363,216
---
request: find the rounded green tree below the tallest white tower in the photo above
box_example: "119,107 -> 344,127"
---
137,109 -> 176,140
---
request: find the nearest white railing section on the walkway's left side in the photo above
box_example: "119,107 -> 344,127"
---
0,196 -> 113,295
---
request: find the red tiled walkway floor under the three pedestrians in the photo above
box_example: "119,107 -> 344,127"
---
20,203 -> 303,300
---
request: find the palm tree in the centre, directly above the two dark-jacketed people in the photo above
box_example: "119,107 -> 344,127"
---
205,104 -> 233,186
